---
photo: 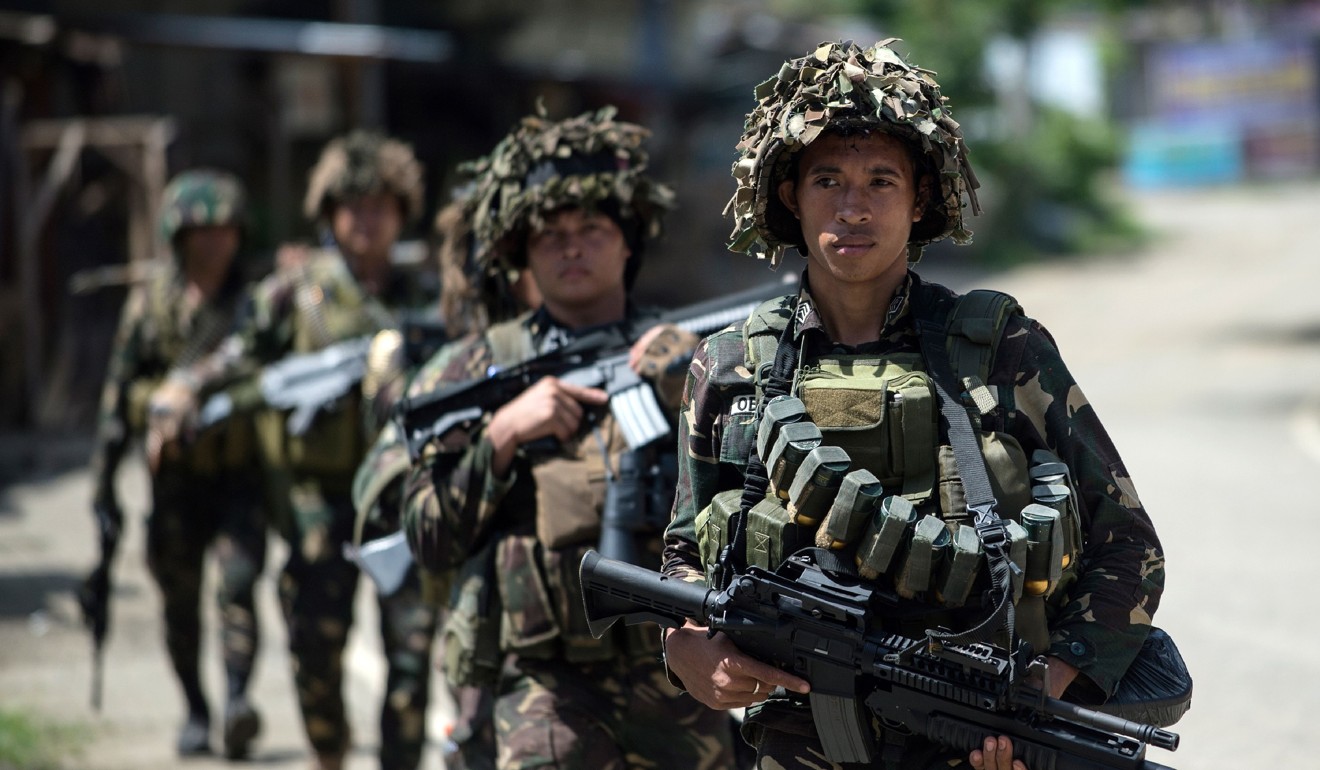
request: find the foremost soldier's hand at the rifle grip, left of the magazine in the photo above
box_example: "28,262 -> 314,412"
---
665,621 -> 810,711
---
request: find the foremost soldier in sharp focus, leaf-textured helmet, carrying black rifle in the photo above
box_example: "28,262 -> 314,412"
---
664,41 -> 1164,770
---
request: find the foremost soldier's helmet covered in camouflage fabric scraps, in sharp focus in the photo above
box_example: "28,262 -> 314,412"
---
725,38 -> 981,265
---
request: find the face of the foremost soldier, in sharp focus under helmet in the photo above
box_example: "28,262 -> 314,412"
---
779,133 -> 921,287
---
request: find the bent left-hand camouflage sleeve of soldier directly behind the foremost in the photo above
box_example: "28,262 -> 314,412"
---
403,334 -> 520,572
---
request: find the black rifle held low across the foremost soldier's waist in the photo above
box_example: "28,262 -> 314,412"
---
581,551 -> 1179,770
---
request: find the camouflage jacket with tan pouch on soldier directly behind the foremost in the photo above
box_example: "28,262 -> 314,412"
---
403,306 -> 672,660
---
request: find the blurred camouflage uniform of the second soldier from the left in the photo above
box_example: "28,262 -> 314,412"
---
178,251 -> 434,767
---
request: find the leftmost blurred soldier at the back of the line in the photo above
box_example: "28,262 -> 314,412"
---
92,169 -> 265,759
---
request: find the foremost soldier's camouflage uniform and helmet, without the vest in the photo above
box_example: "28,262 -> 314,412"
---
664,44 -> 1164,769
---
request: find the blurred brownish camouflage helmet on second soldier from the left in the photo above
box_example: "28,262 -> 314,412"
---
302,129 -> 424,222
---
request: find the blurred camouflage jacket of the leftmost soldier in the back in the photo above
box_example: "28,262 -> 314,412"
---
92,264 -> 243,494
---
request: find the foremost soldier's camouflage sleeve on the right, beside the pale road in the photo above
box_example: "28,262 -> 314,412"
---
991,321 -> 1164,697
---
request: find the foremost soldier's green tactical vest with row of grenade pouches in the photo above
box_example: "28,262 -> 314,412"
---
696,284 -> 1081,650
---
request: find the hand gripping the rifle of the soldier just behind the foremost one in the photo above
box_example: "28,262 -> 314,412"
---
486,376 -> 610,477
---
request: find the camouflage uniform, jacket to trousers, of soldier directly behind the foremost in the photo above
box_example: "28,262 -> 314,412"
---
404,312 -> 731,769
